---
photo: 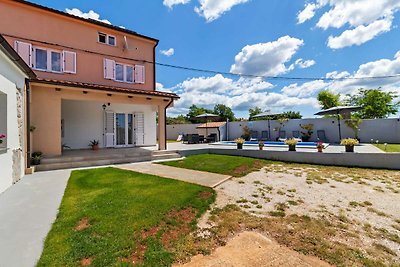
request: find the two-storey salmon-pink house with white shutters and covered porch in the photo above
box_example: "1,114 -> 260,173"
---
0,0 -> 178,159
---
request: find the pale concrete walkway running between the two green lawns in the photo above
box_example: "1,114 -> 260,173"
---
115,162 -> 231,187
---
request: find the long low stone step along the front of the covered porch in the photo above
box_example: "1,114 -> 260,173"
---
36,155 -> 152,171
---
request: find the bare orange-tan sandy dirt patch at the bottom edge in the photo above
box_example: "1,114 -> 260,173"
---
175,232 -> 331,267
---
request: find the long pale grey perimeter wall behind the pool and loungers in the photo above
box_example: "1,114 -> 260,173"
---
167,118 -> 400,144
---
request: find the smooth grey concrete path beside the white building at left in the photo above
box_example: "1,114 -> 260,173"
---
0,170 -> 71,267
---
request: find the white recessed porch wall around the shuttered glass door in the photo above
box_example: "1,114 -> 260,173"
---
61,100 -> 157,149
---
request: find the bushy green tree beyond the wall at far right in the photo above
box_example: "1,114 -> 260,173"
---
348,88 -> 400,119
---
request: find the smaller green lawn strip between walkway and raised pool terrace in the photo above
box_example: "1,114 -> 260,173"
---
160,154 -> 272,177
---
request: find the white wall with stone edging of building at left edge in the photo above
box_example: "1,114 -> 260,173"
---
0,51 -> 25,193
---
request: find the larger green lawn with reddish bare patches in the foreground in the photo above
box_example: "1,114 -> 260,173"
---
38,168 -> 215,266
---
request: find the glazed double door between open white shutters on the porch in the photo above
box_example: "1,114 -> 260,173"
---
115,113 -> 134,147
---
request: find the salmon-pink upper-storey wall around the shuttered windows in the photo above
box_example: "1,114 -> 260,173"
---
0,0 -> 156,91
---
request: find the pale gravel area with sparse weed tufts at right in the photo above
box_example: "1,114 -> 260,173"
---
216,164 -> 400,260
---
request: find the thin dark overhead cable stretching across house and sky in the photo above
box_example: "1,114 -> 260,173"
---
1,33 -> 400,81
